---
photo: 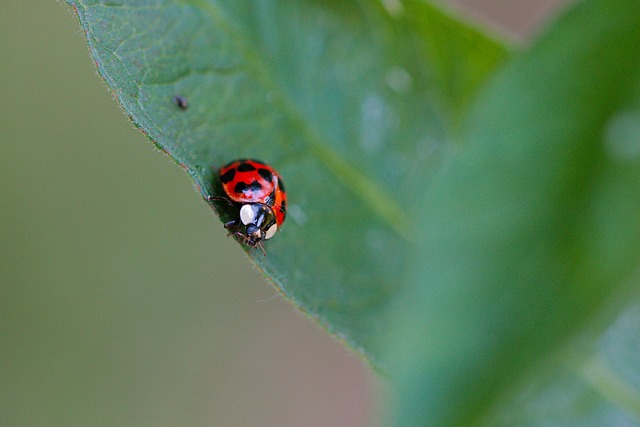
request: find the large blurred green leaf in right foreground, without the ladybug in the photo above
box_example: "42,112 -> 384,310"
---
387,0 -> 640,426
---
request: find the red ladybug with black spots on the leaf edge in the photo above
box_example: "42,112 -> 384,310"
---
218,159 -> 287,255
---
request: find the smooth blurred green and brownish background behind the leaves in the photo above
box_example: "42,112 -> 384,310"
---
0,0 -> 559,427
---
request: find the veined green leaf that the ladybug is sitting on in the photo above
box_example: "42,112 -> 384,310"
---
69,0 -> 506,368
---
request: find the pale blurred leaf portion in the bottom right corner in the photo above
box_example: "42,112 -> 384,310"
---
489,302 -> 640,427
